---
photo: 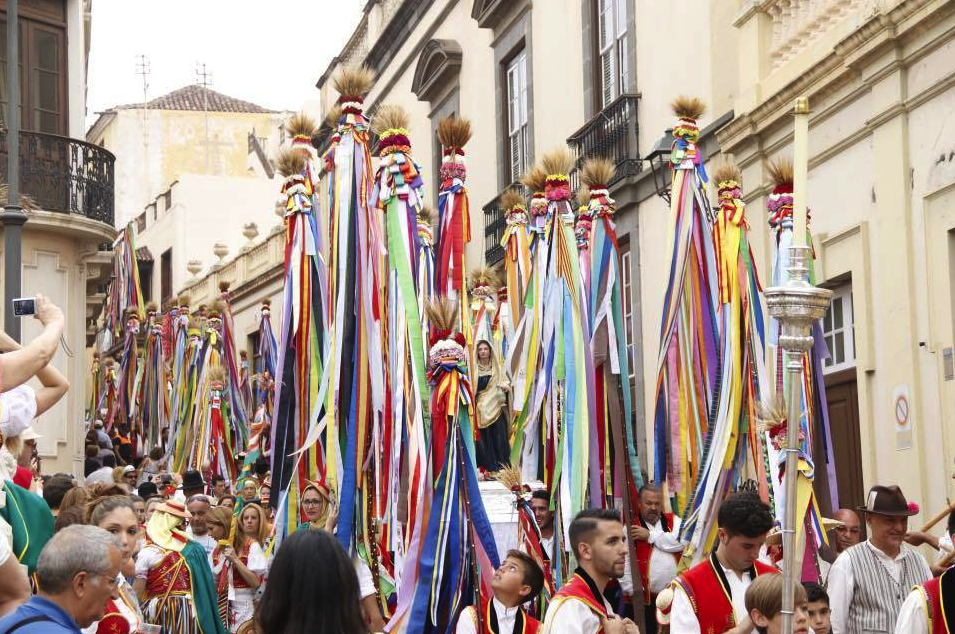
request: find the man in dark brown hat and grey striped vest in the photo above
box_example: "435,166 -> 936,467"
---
829,485 -> 932,634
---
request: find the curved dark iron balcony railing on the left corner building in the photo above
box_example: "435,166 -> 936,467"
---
0,130 -> 116,227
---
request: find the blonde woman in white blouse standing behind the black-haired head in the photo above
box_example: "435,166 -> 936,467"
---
212,502 -> 269,633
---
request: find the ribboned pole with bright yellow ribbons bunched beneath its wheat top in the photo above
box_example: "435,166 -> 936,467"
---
682,164 -> 770,565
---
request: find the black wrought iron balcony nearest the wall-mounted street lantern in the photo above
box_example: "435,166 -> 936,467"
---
567,95 -> 641,191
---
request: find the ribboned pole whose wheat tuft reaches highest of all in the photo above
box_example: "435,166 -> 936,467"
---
322,67 -> 387,556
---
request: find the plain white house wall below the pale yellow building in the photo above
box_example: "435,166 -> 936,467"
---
136,174 -> 280,299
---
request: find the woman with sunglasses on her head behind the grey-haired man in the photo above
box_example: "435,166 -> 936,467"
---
83,495 -> 143,634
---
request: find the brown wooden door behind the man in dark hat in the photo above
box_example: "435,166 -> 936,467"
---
826,369 -> 866,509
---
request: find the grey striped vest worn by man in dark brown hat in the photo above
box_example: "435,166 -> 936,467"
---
840,542 -> 932,634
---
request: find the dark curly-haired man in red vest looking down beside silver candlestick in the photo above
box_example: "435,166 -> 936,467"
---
670,492 -> 779,634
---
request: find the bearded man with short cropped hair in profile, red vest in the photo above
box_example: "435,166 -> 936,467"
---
544,509 -> 639,634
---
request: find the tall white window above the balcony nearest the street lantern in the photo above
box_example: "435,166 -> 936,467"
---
595,0 -> 630,108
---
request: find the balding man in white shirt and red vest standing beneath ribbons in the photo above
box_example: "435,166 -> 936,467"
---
620,484 -> 684,634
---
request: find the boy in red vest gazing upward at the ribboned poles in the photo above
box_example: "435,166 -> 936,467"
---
455,550 -> 544,634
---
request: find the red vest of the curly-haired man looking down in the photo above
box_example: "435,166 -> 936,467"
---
676,553 -> 779,634
